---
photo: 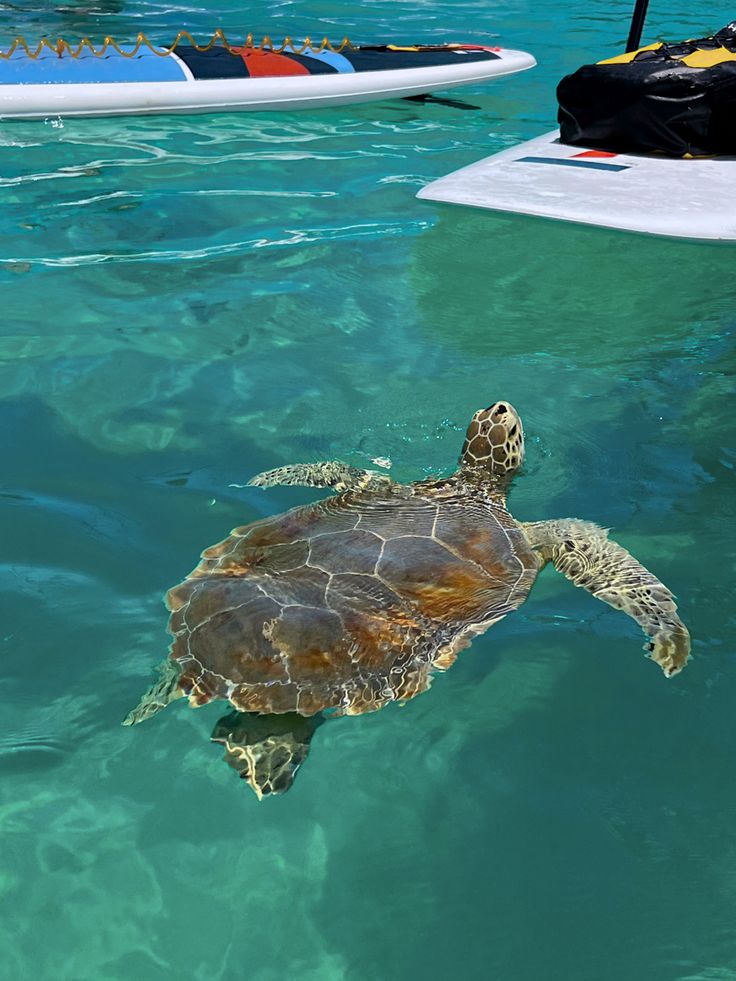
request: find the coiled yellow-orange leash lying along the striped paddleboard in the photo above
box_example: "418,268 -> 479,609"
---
0,27 -> 354,60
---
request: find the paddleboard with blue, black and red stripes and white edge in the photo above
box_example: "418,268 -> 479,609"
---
0,32 -> 536,119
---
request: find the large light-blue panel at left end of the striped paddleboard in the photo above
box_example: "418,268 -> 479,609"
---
0,45 -> 186,85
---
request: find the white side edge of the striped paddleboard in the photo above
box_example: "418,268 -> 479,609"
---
0,48 -> 536,119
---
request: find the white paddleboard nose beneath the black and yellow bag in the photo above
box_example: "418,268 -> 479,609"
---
417,131 -> 736,241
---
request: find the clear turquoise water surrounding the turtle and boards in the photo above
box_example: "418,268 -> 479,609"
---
0,0 -> 736,981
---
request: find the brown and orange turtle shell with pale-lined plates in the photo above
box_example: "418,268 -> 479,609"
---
167,487 -> 540,715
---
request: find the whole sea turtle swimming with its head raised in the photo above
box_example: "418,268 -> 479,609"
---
124,402 -> 690,798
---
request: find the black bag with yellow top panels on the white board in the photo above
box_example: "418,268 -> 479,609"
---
557,21 -> 736,157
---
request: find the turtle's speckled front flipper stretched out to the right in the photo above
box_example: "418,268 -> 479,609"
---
523,518 -> 690,678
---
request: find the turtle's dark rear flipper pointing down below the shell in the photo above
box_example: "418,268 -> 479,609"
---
211,712 -> 324,800
